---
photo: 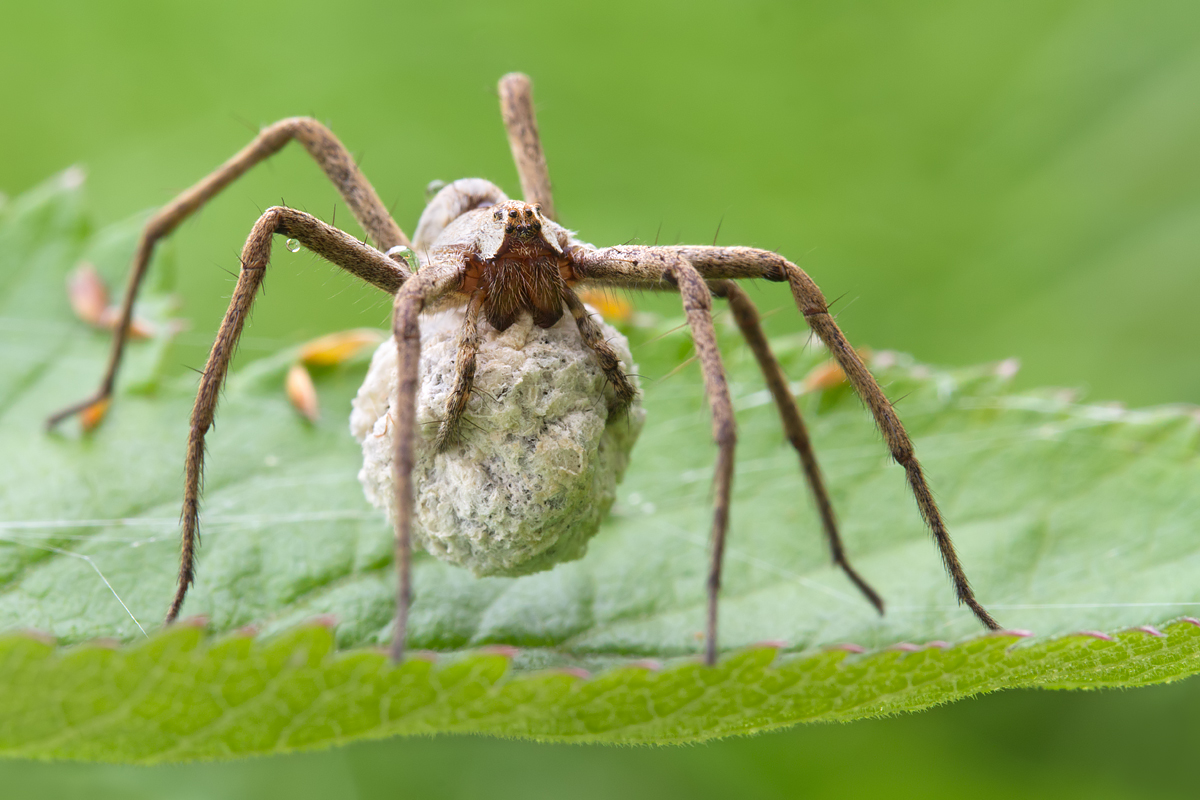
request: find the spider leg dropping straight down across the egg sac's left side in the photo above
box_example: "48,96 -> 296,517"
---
391,263 -> 463,663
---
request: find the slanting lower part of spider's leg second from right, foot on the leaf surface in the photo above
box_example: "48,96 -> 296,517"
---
709,281 -> 883,614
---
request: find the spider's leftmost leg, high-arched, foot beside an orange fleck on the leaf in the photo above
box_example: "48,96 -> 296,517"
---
46,116 -> 408,428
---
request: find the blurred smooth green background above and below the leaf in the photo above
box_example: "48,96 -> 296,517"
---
0,0 -> 1200,799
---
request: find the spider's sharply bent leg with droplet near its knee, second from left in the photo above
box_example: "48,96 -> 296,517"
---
167,207 -> 409,622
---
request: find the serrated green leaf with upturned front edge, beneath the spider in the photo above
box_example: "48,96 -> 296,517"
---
0,173 -> 1200,762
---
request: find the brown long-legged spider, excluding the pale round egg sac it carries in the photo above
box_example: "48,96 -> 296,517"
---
48,73 -> 1000,664
